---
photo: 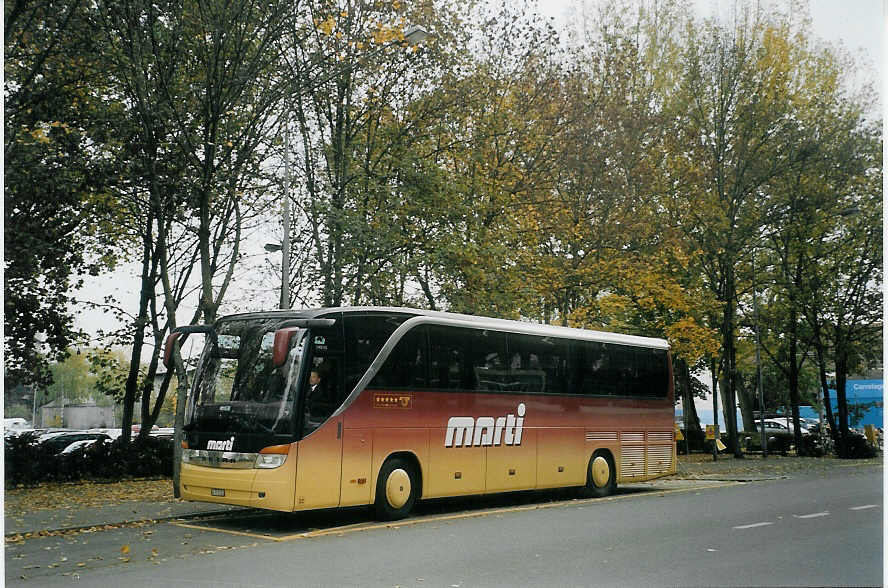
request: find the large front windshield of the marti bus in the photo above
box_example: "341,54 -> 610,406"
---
185,320 -> 306,444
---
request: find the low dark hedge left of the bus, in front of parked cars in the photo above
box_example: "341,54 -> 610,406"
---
5,433 -> 173,487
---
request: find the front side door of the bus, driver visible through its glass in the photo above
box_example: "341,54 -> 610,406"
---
296,340 -> 346,510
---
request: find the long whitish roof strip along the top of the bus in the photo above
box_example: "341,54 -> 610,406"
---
220,306 -> 669,349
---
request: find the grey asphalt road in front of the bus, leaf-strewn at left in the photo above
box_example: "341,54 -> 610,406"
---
5,467 -> 884,587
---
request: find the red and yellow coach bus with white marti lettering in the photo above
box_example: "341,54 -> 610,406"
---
165,308 -> 675,519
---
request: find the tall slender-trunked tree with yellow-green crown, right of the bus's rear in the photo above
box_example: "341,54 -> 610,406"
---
672,7 -> 820,456
